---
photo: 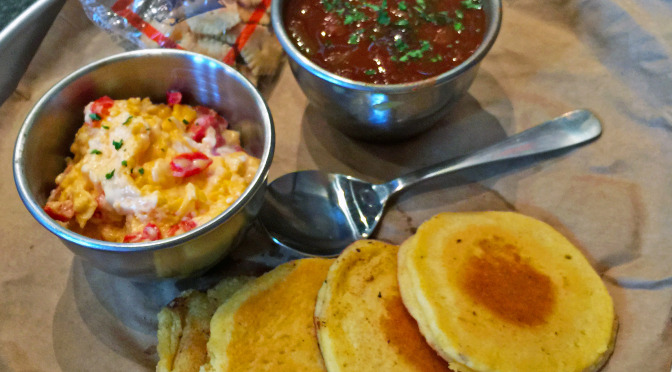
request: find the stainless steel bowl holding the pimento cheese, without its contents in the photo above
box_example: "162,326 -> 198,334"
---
14,49 -> 275,280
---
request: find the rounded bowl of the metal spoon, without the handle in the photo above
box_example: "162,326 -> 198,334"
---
260,170 -> 389,253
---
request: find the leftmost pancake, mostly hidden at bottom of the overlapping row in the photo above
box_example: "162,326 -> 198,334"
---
156,277 -> 252,372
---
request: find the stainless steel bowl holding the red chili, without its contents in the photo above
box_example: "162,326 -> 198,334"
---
271,0 -> 502,141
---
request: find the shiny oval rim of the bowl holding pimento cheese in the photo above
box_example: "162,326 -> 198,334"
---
12,49 -> 275,252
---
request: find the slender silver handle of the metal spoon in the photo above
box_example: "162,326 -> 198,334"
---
380,110 -> 602,197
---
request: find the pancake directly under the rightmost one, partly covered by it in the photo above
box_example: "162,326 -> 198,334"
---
315,240 -> 450,372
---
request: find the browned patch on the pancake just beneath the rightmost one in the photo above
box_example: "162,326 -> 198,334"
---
381,296 -> 451,371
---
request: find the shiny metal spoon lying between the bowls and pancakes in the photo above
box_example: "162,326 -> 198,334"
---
259,110 -> 602,257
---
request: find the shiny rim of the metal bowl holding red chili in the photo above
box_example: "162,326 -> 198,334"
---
271,0 -> 502,93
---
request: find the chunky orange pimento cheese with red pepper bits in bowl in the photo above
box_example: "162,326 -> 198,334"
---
44,92 -> 260,242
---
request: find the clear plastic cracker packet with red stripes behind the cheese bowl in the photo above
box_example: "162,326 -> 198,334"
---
80,0 -> 283,85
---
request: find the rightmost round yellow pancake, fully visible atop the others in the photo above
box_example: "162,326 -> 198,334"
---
399,212 -> 617,372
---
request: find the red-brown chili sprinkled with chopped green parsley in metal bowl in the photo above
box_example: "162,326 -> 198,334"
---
283,0 -> 486,84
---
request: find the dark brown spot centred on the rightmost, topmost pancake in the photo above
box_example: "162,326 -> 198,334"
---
462,236 -> 555,326
